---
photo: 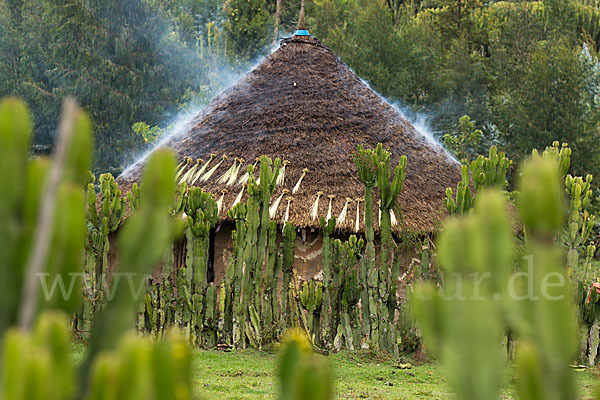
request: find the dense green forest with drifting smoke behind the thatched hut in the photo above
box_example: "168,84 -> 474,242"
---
0,0 -> 600,181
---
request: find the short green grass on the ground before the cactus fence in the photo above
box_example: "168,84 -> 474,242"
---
73,344 -> 600,400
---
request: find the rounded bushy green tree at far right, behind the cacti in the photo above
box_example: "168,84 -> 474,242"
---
498,41 -> 600,180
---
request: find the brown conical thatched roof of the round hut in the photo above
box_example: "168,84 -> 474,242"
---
118,36 -> 460,231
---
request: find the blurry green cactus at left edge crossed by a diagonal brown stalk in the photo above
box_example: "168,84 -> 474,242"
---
0,99 -> 92,334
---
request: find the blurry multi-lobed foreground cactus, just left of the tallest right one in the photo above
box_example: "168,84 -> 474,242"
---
411,192 -> 513,399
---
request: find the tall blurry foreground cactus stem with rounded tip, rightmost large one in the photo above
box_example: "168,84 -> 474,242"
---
517,155 -> 577,399
